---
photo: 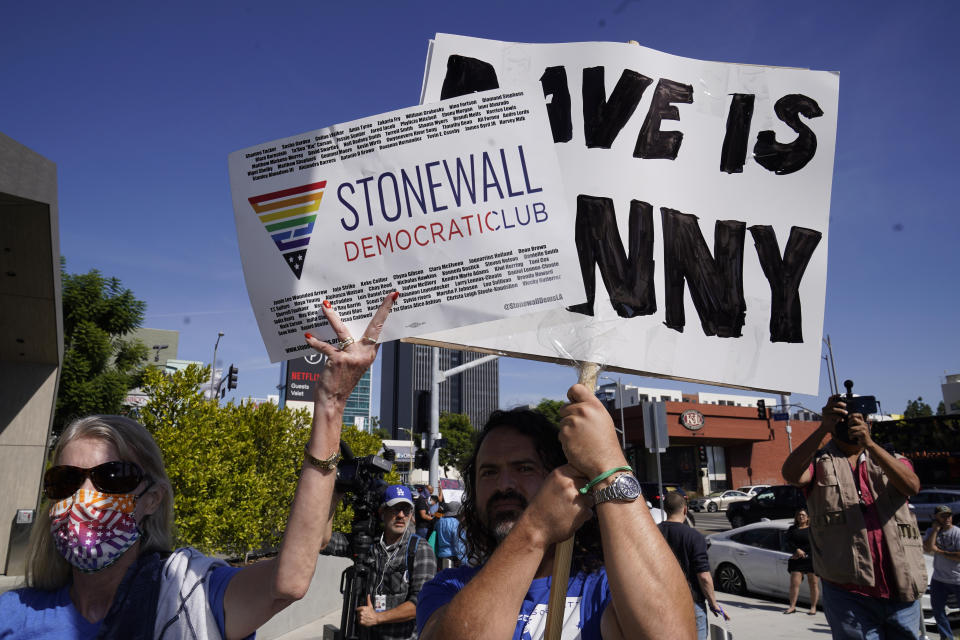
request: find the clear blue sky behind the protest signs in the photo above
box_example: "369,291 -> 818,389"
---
0,0 -> 960,413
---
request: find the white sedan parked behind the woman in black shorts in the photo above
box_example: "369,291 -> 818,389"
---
707,519 -> 810,605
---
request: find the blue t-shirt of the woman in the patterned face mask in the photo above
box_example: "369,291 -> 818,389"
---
0,567 -> 240,640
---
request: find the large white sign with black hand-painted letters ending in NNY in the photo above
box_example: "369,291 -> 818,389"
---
418,34 -> 839,393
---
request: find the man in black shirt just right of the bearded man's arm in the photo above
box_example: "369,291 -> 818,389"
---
657,492 -> 730,640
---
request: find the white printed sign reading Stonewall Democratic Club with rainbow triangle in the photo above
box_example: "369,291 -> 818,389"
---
230,89 -> 584,362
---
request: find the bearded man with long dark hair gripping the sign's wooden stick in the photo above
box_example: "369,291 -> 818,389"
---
417,385 -> 696,640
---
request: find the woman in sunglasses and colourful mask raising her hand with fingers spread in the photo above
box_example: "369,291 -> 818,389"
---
0,292 -> 399,640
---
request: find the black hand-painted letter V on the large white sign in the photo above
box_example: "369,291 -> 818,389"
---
581,67 -> 653,149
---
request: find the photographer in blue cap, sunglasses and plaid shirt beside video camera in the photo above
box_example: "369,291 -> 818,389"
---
325,485 -> 437,640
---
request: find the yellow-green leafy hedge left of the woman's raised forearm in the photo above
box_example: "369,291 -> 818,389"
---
137,365 -> 310,557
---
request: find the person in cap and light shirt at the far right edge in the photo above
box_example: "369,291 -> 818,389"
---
923,504 -> 960,640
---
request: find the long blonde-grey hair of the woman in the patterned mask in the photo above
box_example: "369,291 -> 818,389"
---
26,416 -> 173,590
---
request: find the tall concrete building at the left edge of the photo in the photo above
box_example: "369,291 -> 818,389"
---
0,134 -> 63,574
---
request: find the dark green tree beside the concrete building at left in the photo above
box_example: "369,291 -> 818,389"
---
54,260 -> 148,434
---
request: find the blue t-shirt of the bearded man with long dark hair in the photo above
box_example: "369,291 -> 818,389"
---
417,567 -> 610,640
